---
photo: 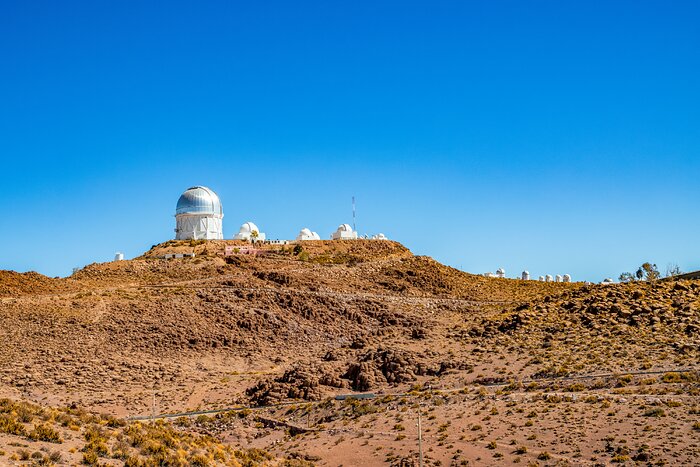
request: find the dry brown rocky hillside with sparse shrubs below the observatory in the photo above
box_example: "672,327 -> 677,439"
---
0,241 -> 700,466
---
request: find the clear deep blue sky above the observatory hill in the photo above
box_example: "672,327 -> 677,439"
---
0,0 -> 700,280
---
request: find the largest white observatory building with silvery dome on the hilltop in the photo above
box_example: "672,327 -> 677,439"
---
175,186 -> 224,240
